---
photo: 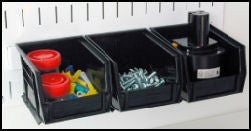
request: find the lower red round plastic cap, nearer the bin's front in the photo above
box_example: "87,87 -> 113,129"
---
41,73 -> 71,98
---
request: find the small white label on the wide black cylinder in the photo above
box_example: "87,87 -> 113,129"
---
197,67 -> 220,79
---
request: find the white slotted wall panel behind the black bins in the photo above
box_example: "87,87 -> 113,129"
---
2,2 -> 249,128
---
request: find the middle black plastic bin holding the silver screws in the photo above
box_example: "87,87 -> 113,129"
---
86,29 -> 182,111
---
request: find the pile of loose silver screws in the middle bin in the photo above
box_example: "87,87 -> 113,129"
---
120,68 -> 165,91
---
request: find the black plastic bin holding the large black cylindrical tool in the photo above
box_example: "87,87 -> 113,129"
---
151,24 -> 246,102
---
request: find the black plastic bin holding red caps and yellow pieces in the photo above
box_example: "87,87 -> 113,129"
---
17,36 -> 112,123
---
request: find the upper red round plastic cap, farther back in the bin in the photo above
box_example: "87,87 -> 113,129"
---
27,49 -> 61,70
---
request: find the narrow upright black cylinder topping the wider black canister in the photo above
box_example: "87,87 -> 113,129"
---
188,11 -> 210,48
